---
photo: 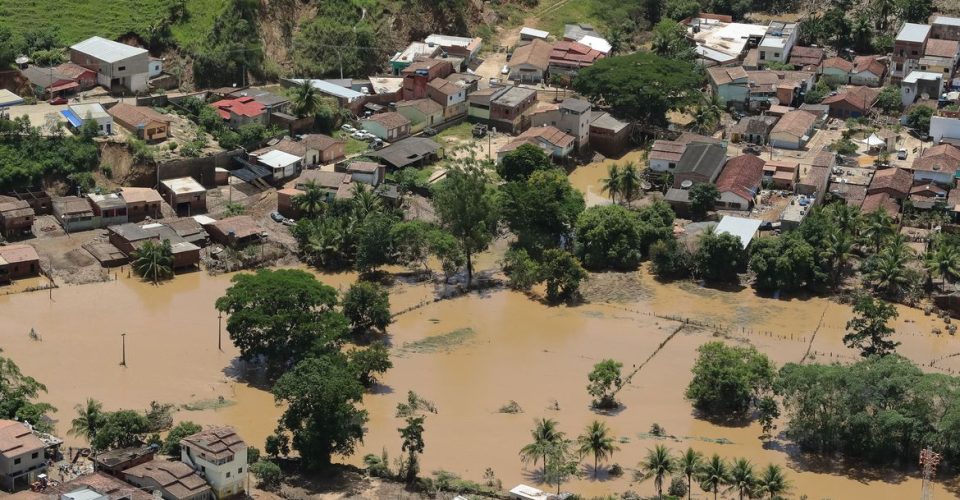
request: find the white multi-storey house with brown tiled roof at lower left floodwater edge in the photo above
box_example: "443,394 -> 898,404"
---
180,427 -> 247,498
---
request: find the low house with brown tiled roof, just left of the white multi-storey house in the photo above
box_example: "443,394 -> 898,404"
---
123,460 -> 212,500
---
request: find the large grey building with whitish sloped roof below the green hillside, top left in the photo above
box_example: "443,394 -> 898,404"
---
70,36 -> 150,92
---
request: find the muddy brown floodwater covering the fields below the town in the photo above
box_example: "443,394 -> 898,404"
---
0,264 -> 960,499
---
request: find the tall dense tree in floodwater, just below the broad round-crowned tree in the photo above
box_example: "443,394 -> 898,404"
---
273,353 -> 367,469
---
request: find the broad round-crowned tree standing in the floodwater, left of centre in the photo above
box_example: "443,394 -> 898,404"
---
216,269 -> 349,376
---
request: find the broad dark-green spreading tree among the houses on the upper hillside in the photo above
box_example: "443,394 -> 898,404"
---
573,52 -> 703,125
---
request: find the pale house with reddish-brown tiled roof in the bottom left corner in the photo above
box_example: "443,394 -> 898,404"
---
0,420 -> 47,491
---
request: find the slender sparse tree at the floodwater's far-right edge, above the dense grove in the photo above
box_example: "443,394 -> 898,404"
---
843,294 -> 900,358
